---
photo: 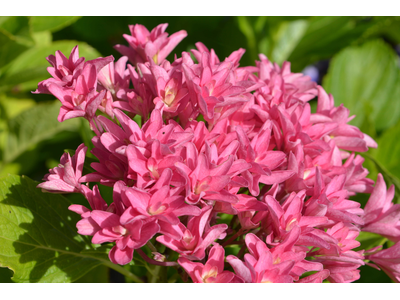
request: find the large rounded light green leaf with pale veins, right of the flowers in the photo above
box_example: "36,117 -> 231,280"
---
323,40 -> 400,130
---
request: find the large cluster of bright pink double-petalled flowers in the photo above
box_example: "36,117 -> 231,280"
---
36,24 -> 400,283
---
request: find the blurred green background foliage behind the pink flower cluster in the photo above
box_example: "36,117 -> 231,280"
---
0,16 -> 400,282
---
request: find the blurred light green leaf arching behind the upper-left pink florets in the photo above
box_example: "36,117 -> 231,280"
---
0,41 -> 101,91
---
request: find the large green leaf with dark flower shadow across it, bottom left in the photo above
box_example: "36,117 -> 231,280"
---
0,175 -> 140,282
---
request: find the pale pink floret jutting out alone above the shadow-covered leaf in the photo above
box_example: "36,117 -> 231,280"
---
37,144 -> 87,193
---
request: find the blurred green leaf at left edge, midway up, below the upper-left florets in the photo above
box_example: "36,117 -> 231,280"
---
3,101 -> 79,163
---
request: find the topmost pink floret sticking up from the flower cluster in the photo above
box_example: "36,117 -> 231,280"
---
115,24 -> 187,65
